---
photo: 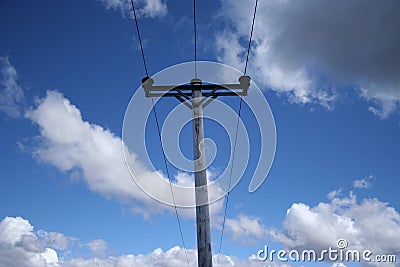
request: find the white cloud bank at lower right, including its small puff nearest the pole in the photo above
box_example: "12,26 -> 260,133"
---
219,190 -> 400,266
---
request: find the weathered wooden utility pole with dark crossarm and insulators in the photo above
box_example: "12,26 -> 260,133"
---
142,76 -> 250,267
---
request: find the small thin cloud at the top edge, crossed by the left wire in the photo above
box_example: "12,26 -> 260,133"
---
98,0 -> 167,18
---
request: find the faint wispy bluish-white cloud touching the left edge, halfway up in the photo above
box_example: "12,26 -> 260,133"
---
0,57 -> 25,118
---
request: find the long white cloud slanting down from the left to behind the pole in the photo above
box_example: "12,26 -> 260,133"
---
26,91 -> 222,218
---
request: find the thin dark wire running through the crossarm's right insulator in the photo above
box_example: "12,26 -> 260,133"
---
217,0 -> 258,265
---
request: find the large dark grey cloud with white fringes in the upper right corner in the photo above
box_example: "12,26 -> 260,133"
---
216,0 -> 400,118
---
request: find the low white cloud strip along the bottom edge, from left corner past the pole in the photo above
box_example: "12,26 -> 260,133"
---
0,217 -> 263,267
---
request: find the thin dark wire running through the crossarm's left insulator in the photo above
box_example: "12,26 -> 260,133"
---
131,0 -> 189,266
